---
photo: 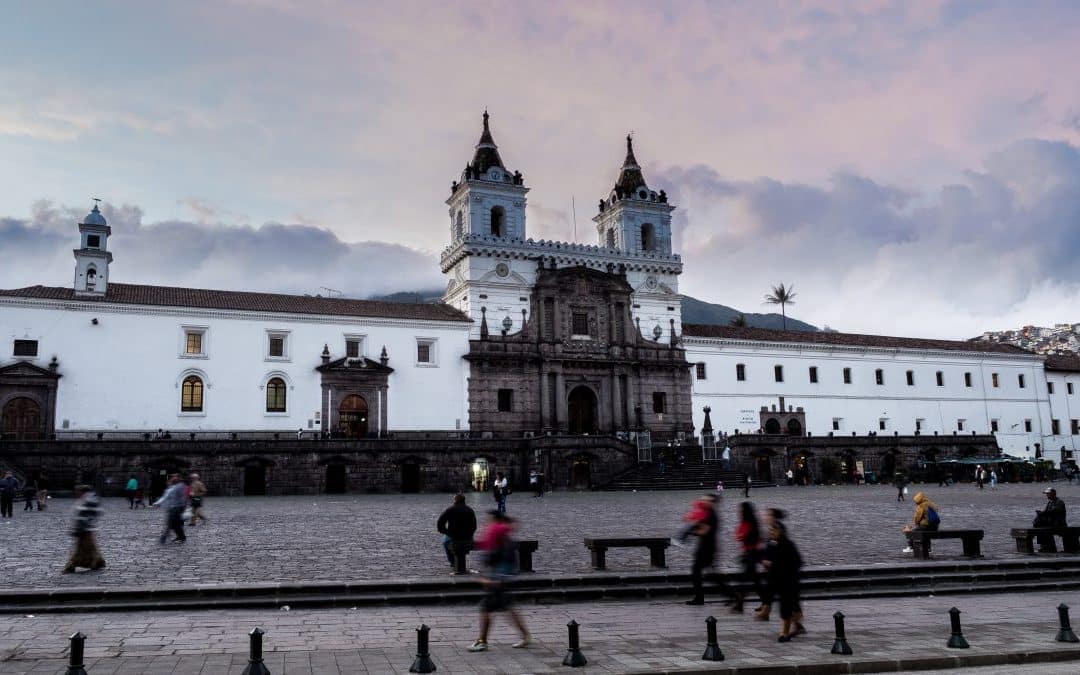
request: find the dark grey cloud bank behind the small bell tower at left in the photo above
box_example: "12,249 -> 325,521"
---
0,202 -> 445,297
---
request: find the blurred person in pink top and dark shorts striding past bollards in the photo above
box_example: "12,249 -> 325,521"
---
469,511 -> 532,651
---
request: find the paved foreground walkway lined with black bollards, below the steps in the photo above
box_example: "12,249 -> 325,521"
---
0,593 -> 1080,675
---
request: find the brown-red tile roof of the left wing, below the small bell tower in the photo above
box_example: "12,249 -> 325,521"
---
0,283 -> 471,322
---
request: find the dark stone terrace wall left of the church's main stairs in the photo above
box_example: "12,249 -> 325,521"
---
0,436 -> 635,497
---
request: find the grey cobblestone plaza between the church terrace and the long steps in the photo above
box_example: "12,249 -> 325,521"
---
0,483 -> 1080,589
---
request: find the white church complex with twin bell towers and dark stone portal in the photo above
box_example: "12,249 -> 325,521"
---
0,112 -> 1080,489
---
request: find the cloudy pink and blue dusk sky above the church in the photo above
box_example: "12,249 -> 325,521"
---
0,0 -> 1080,339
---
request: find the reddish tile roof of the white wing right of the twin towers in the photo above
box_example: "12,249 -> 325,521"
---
683,323 -> 1031,355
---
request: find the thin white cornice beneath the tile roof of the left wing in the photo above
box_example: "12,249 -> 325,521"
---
0,296 -> 471,334
